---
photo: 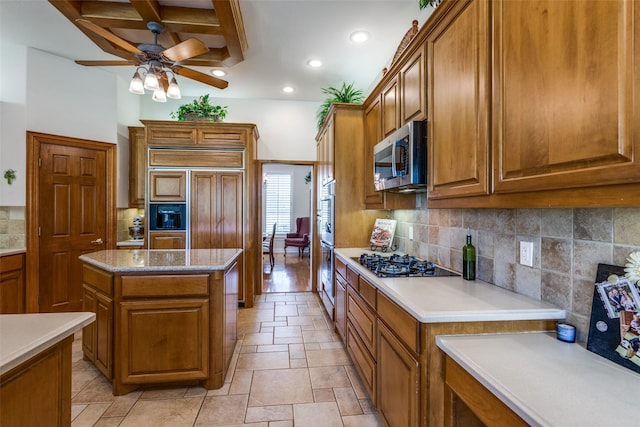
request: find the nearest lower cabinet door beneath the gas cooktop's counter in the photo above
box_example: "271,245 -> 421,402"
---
378,321 -> 420,426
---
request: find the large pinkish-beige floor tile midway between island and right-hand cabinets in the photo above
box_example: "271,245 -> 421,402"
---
249,368 -> 313,406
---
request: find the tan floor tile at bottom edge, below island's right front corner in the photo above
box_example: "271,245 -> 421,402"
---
194,394 -> 248,426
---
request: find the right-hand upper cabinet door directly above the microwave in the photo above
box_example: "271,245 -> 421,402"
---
400,44 -> 427,124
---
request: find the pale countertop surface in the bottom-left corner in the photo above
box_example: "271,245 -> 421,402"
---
0,312 -> 96,374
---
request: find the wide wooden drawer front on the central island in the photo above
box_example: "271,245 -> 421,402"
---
121,274 -> 209,298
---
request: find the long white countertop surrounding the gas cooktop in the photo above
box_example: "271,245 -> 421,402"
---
335,248 -> 567,323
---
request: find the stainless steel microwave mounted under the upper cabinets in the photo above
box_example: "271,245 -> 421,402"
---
373,121 -> 427,193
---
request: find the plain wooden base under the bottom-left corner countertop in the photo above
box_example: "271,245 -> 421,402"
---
0,336 -> 73,427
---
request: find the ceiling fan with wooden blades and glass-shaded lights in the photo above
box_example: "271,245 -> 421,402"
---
75,19 -> 228,98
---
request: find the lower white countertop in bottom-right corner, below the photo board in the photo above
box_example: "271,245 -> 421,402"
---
436,333 -> 640,426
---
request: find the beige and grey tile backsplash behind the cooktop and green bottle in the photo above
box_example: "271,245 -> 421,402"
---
393,195 -> 640,341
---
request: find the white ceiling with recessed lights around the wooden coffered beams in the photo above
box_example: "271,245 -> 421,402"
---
0,0 -> 431,101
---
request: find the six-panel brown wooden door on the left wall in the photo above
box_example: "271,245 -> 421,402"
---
38,143 -> 107,312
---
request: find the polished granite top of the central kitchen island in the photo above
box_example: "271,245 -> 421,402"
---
79,249 -> 242,273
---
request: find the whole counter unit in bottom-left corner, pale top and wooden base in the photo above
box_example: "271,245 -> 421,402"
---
0,313 -> 95,426
